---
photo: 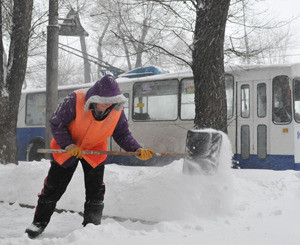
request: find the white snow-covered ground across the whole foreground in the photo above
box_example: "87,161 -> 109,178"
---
0,136 -> 300,245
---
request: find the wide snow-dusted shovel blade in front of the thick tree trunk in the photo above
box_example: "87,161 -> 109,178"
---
183,129 -> 222,174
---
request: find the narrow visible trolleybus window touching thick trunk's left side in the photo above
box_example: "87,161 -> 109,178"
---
180,78 -> 195,120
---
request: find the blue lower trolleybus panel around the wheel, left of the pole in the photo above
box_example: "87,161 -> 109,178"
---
17,127 -> 45,161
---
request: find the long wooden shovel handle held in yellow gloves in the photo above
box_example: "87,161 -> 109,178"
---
37,149 -> 189,157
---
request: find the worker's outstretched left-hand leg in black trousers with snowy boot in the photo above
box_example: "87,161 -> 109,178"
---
25,161 -> 78,237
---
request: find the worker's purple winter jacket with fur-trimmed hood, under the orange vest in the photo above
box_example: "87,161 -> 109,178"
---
49,75 -> 141,167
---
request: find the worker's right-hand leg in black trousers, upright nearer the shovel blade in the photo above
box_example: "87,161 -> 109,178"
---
81,159 -> 105,226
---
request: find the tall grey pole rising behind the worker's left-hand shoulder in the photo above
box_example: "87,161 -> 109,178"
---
45,0 -> 59,153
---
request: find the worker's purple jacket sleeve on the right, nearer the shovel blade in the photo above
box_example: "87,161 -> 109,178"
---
113,111 -> 142,151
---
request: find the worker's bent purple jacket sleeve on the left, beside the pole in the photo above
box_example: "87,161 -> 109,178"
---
49,92 -> 76,149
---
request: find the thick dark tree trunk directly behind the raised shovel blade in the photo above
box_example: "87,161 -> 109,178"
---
192,0 -> 230,132
